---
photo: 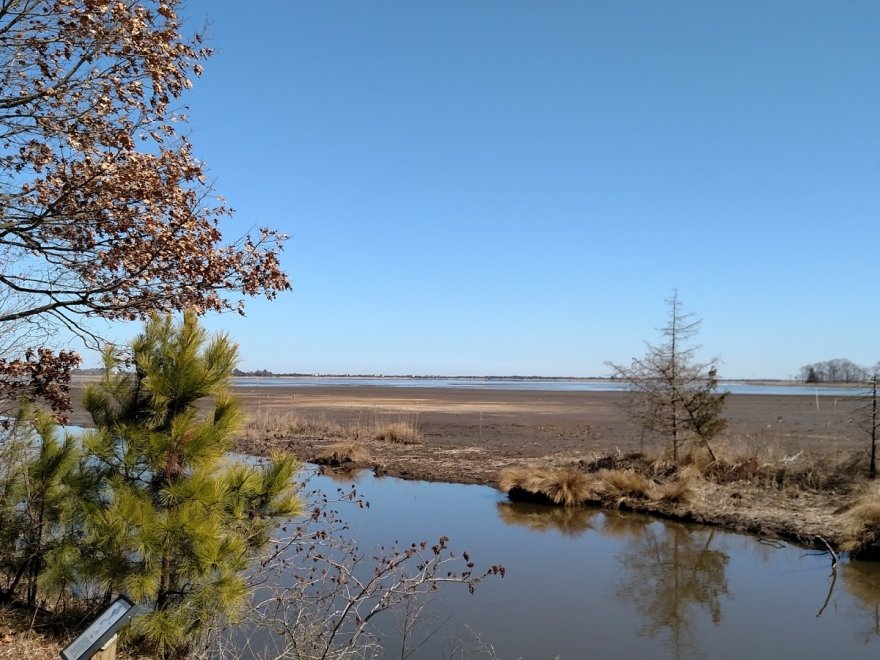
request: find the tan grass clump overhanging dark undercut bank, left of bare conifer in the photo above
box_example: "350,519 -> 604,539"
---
498,467 -> 599,506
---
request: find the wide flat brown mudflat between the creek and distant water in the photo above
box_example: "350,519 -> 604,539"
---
227,386 -> 867,483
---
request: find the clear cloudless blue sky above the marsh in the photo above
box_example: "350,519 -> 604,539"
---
99,0 -> 880,378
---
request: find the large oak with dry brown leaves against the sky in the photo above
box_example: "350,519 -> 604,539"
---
0,0 -> 290,418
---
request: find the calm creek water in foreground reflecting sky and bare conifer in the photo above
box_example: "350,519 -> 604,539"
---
284,472 -> 880,659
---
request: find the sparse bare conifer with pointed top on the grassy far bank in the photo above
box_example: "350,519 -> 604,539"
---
608,291 -> 727,461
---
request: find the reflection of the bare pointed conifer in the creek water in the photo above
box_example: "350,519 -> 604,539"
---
618,523 -> 730,658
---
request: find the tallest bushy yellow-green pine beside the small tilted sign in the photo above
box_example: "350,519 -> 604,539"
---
79,313 -> 301,658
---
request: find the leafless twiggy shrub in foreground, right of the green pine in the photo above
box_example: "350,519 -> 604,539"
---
196,472 -> 505,659
